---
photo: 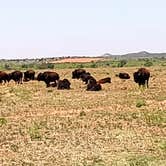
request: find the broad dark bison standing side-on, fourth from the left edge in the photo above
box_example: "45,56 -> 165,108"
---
37,71 -> 59,87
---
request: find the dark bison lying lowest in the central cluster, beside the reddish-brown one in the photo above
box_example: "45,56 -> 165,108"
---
86,78 -> 102,91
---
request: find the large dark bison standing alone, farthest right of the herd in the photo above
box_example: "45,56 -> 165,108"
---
133,68 -> 150,88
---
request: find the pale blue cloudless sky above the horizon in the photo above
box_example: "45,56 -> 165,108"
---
0,0 -> 166,59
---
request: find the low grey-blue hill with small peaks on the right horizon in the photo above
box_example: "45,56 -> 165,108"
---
102,51 -> 166,59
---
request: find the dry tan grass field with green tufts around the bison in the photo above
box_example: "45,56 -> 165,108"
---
0,67 -> 166,166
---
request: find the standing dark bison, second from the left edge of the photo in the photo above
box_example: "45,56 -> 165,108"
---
8,70 -> 23,84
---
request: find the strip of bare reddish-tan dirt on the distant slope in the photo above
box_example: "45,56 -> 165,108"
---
51,58 -> 103,63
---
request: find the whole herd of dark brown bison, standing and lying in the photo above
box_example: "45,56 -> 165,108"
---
0,68 -> 150,91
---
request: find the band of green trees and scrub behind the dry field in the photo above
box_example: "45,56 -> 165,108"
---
0,58 -> 166,70
